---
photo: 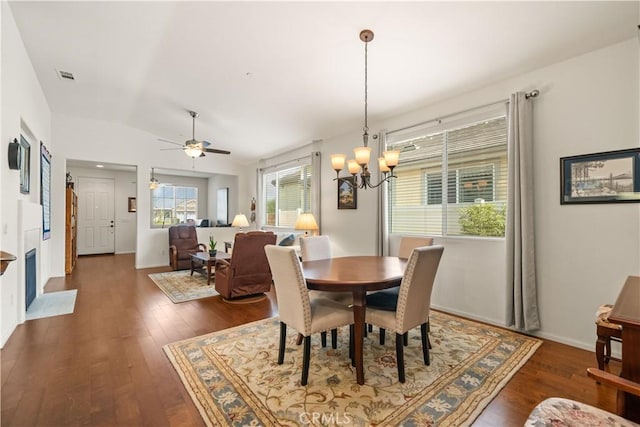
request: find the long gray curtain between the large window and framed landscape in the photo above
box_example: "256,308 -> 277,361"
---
506,92 -> 540,331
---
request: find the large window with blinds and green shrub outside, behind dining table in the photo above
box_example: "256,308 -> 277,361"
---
387,112 -> 507,236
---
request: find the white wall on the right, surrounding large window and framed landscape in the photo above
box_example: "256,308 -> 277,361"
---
314,39 -> 640,350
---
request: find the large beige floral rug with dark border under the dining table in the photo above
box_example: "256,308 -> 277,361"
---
164,311 -> 541,427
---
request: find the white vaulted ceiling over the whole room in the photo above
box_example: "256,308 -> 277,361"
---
10,1 -> 639,161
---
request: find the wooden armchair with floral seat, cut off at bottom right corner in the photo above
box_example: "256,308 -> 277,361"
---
524,368 -> 640,427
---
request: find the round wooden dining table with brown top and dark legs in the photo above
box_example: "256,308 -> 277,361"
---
302,256 -> 407,385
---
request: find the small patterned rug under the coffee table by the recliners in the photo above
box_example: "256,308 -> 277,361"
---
149,270 -> 219,304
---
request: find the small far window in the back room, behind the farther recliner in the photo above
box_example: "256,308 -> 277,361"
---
151,185 -> 198,227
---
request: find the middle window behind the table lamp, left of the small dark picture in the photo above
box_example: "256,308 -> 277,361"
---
262,160 -> 312,227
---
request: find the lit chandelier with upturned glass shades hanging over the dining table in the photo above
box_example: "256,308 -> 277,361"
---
331,30 -> 400,189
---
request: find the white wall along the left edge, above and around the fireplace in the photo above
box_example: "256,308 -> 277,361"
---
0,2 -> 52,346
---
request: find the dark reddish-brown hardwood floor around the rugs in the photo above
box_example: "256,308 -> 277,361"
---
0,255 -> 619,427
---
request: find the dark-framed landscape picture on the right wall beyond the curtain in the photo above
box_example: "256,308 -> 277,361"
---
560,148 -> 640,205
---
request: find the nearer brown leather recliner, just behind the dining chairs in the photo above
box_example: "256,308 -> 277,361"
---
215,231 -> 276,299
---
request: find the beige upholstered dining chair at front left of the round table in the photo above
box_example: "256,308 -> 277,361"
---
264,245 -> 353,385
